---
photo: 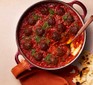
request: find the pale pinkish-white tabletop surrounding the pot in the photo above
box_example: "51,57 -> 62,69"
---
0,0 -> 93,85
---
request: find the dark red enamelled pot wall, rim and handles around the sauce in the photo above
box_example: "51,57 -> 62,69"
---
15,1 -> 87,70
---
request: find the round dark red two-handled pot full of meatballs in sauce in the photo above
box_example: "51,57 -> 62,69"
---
15,1 -> 87,70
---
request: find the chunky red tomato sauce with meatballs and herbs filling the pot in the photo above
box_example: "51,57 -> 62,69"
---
18,2 -> 84,68
